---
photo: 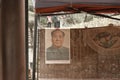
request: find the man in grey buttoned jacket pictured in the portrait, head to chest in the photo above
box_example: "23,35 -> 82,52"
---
46,29 -> 69,60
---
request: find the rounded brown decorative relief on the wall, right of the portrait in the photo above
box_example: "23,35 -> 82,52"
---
85,26 -> 120,54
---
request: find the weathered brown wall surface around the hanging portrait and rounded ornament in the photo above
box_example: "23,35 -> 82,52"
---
38,29 -> 120,80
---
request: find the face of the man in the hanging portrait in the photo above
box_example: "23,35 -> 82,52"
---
52,30 -> 64,48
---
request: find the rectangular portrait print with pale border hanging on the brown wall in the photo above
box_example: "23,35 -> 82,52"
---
45,29 -> 70,64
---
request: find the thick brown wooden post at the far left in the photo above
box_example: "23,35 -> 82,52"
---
1,0 -> 26,80
